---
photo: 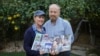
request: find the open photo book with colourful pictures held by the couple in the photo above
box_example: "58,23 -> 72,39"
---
31,33 -> 71,53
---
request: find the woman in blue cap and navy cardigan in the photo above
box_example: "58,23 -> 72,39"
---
24,10 -> 45,56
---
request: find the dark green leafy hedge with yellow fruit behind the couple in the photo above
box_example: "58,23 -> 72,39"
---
0,0 -> 100,42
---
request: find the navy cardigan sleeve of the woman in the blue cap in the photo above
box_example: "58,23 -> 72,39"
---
24,30 -> 39,55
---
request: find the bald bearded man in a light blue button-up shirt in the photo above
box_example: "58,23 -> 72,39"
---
44,4 -> 74,56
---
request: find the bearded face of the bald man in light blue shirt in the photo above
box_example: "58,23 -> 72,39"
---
49,8 -> 60,21
